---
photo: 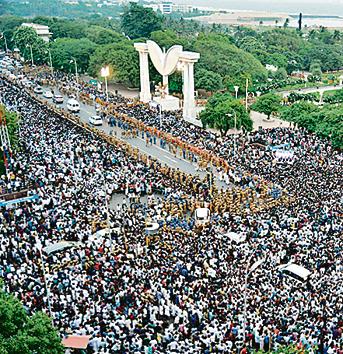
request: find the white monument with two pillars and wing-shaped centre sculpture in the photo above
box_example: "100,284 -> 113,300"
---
135,41 -> 200,120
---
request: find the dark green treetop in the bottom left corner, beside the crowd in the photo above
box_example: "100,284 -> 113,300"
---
0,282 -> 64,354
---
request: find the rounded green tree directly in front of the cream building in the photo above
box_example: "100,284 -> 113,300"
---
13,26 -> 47,64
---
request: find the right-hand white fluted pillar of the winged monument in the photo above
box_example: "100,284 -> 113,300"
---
180,52 -> 200,120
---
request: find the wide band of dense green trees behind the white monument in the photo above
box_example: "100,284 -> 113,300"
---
0,3 -> 343,93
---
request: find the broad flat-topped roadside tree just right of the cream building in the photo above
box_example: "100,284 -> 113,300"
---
50,38 -> 96,72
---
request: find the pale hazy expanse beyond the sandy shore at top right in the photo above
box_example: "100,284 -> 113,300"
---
174,0 -> 343,16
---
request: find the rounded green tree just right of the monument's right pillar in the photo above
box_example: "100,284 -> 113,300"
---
200,93 -> 253,136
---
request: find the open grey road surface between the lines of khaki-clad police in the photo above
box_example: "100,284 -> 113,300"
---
37,86 -> 227,189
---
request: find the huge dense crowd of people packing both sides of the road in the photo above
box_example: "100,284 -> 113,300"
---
0,70 -> 343,354
